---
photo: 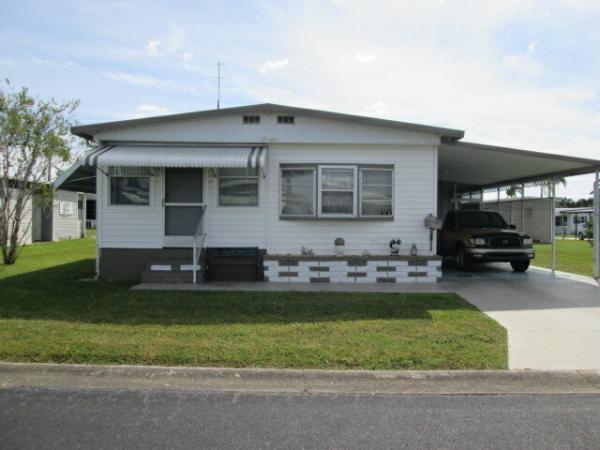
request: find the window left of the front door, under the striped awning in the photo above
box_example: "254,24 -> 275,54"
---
109,167 -> 150,206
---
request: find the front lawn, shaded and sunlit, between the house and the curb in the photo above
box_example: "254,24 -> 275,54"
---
0,239 -> 507,369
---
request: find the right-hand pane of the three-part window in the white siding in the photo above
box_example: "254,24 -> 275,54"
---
360,168 -> 393,217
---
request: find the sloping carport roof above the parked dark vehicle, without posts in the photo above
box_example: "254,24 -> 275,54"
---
438,141 -> 600,189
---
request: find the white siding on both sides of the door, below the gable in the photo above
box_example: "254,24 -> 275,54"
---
98,144 -> 437,254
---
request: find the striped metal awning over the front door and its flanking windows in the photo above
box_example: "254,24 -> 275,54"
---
80,145 -> 267,168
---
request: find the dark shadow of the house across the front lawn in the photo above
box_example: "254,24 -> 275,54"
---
0,260 -> 476,325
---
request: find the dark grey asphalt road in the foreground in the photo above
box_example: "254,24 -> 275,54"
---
0,388 -> 600,449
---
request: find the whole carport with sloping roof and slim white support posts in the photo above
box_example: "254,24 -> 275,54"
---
438,140 -> 600,278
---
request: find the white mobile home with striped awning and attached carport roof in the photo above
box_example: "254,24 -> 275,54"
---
55,104 -> 595,283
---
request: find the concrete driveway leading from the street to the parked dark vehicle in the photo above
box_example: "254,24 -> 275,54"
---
441,264 -> 600,370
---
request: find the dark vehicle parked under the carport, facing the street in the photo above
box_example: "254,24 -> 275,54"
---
439,209 -> 535,272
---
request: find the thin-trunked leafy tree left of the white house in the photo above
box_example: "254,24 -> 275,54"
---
0,80 -> 79,264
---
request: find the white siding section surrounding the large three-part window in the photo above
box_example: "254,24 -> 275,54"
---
266,144 -> 437,254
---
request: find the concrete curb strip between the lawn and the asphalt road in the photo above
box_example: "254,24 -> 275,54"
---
0,362 -> 600,395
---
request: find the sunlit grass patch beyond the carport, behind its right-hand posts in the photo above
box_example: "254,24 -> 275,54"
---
532,239 -> 593,276
